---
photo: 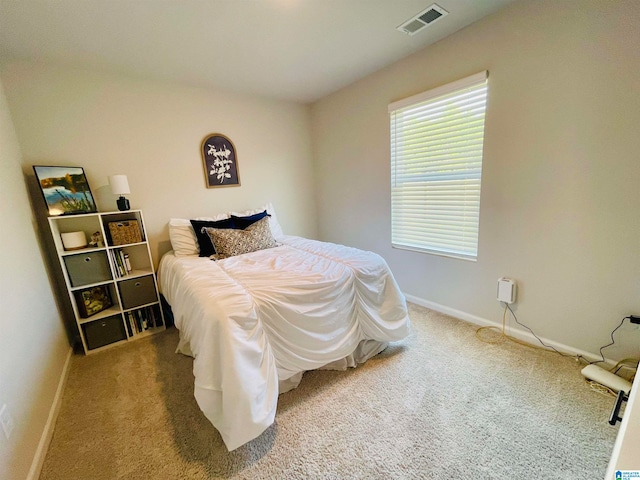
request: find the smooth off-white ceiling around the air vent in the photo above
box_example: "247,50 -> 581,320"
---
0,0 -> 513,103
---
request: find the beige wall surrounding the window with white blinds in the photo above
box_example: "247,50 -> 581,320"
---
312,0 -> 640,358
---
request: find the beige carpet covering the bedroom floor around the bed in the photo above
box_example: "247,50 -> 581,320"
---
40,305 -> 617,480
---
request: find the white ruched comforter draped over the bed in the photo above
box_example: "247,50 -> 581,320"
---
159,236 -> 409,450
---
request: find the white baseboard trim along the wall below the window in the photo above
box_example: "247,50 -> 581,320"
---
404,293 -> 616,366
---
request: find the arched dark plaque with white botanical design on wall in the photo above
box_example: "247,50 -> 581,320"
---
200,133 -> 240,188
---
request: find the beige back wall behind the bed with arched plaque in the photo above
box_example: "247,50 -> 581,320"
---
0,62 -> 316,264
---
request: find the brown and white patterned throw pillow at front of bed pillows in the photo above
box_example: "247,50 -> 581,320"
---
205,217 -> 277,259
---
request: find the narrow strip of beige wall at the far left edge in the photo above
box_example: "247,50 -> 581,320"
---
0,78 -> 70,480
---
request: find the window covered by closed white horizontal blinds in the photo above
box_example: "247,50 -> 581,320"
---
389,72 -> 487,260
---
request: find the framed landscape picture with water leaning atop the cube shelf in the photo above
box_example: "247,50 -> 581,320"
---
33,165 -> 98,216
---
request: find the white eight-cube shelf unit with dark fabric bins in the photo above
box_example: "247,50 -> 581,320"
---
49,210 -> 165,354
